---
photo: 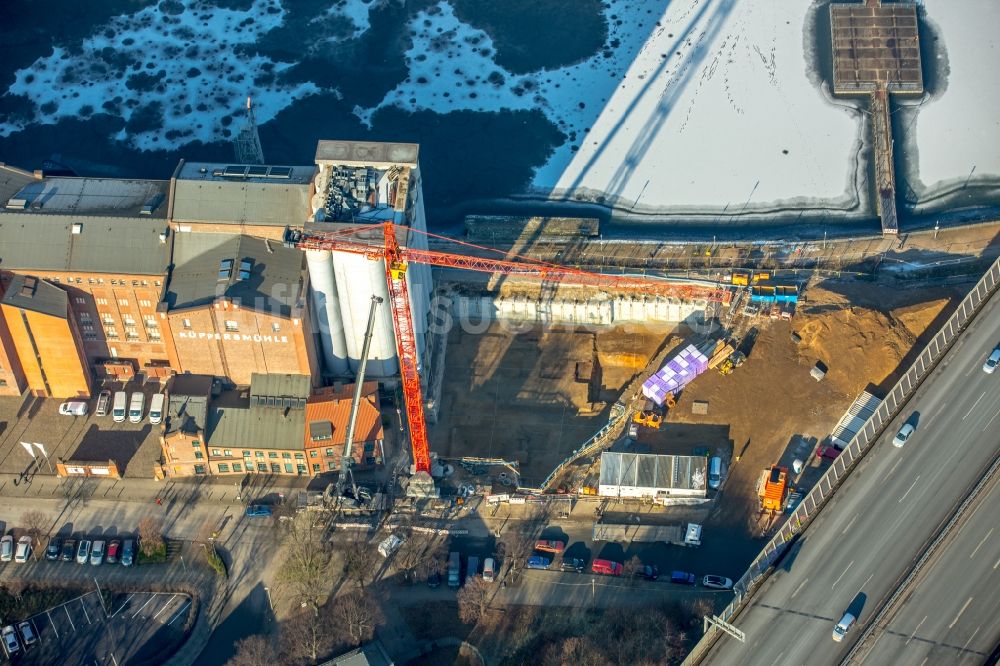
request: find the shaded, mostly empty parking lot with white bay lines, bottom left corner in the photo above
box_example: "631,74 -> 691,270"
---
11,589 -> 191,666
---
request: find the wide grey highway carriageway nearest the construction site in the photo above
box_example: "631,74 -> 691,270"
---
707,298 -> 1000,666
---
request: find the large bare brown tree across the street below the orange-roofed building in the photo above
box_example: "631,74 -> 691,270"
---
277,516 -> 331,613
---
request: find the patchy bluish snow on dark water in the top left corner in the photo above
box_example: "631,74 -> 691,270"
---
0,0 -> 324,150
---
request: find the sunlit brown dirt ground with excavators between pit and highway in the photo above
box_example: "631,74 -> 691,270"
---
656,281 -> 968,534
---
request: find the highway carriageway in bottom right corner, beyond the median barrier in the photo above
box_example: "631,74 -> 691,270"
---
861,472 -> 1000,665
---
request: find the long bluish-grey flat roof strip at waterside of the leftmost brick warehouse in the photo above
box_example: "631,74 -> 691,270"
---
4,176 -> 170,220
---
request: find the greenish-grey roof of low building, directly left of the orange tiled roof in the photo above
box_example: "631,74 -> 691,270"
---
208,382 -> 306,449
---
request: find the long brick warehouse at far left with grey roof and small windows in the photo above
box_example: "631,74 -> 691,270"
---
0,167 -> 170,395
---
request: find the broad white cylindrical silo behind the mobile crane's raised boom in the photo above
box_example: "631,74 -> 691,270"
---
333,252 -> 399,379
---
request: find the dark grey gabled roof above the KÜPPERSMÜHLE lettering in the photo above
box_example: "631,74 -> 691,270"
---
165,232 -> 305,317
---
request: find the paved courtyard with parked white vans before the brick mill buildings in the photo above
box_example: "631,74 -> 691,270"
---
0,381 -> 163,479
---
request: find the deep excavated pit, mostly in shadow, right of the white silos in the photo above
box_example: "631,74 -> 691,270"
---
430,323 -> 674,485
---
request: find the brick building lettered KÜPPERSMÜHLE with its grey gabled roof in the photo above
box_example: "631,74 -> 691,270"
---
158,232 -> 319,386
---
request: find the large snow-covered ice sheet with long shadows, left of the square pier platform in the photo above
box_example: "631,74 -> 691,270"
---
355,0 -> 863,213
